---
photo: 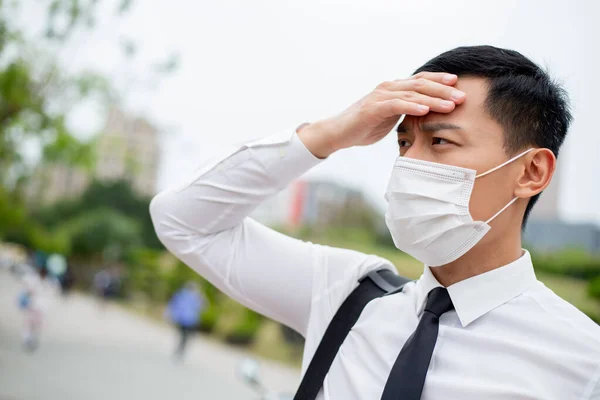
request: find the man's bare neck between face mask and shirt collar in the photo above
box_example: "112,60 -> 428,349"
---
430,230 -> 522,287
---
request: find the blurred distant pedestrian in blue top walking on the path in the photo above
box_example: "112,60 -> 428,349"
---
167,282 -> 206,360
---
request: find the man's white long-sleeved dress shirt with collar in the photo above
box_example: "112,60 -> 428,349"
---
150,129 -> 600,400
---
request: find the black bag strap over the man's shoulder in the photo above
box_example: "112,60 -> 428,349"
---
294,269 -> 410,400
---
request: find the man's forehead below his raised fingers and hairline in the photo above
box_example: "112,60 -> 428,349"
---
402,77 -> 502,136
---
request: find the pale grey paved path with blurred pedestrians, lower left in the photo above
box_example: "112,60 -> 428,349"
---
0,271 -> 298,400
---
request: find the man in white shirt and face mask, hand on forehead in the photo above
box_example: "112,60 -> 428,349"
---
150,46 -> 600,400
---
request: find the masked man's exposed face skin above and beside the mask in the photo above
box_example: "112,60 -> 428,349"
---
398,77 -> 522,231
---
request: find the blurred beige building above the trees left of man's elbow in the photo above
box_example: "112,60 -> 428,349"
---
28,108 -> 160,204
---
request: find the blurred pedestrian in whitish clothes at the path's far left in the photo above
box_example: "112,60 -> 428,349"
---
18,268 -> 58,351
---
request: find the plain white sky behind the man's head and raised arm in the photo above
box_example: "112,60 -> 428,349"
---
27,0 -> 600,223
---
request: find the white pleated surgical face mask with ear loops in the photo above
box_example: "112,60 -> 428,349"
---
385,149 -> 533,267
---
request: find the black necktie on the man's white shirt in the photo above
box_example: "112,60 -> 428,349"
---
381,287 -> 454,400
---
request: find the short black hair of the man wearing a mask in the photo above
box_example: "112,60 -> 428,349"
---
415,46 -> 572,227
